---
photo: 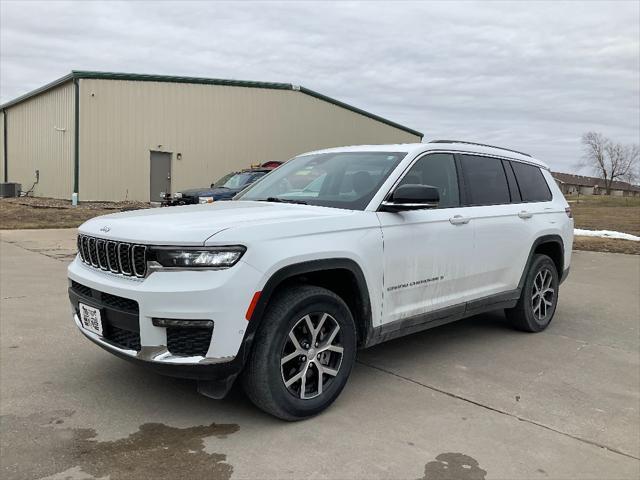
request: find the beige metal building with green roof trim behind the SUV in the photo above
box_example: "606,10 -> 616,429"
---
0,71 -> 422,201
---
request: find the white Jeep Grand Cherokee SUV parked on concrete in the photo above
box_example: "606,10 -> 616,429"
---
69,141 -> 573,420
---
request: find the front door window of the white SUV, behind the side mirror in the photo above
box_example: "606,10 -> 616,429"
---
399,153 -> 460,208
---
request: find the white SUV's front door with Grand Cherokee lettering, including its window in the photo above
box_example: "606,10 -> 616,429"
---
378,153 -> 474,323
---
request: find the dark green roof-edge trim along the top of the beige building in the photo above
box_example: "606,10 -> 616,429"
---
0,70 -> 424,138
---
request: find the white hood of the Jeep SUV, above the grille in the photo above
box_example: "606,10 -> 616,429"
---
78,201 -> 353,245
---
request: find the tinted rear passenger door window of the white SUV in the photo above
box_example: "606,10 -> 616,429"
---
461,155 -> 511,205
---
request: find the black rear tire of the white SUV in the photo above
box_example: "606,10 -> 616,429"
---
505,254 -> 560,332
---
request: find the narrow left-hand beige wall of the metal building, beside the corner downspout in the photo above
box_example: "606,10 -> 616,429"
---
0,82 -> 75,198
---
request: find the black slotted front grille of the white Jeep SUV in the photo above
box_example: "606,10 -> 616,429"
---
78,235 -> 147,278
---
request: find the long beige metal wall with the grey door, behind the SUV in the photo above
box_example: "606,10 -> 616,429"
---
79,79 -> 420,201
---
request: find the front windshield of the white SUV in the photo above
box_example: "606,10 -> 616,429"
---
236,152 -> 406,210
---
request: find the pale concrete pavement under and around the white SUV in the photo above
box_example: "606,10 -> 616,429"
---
0,230 -> 640,480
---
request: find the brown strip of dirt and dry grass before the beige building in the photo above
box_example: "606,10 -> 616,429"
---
0,197 -> 149,230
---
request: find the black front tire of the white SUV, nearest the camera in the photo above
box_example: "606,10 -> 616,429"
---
242,285 -> 357,421
